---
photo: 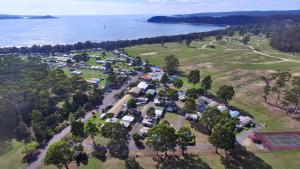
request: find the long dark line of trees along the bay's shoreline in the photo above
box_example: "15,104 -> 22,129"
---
0,30 -> 228,55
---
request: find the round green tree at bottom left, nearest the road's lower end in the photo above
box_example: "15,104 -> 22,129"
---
45,141 -> 73,169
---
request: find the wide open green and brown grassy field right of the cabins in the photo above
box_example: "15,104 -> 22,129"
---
125,36 -> 300,131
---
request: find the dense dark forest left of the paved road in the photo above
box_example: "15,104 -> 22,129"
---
0,57 -> 102,143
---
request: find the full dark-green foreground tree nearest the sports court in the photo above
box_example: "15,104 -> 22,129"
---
209,119 -> 237,153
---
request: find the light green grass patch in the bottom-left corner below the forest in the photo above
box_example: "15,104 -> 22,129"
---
0,139 -> 25,169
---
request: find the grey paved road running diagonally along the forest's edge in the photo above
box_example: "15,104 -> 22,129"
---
26,74 -> 140,169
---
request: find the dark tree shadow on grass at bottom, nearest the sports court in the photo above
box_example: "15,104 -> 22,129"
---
221,145 -> 272,169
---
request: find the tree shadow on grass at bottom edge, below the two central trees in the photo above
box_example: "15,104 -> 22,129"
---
154,154 -> 211,169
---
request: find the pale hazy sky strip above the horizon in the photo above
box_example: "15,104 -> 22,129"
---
0,0 -> 300,15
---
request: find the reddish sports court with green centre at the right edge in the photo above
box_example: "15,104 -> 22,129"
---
256,132 -> 300,150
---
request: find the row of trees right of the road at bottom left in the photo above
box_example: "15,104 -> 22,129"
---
45,121 -> 130,169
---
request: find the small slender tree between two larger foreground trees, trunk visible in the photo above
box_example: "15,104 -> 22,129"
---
176,127 -> 195,155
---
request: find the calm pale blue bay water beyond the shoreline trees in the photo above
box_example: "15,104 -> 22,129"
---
0,16 -> 223,46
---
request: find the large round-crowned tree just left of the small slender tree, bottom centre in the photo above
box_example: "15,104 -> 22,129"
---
146,123 -> 177,155
